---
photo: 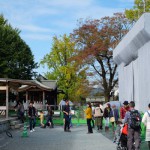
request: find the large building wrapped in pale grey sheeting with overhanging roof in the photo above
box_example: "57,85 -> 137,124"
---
113,13 -> 150,111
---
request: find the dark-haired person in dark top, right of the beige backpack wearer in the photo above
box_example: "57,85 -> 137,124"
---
103,103 -> 111,132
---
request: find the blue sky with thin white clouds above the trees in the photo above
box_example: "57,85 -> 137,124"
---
0,0 -> 134,74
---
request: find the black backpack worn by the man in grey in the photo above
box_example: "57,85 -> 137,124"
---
130,110 -> 141,130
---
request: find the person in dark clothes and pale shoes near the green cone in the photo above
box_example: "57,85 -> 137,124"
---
28,102 -> 37,132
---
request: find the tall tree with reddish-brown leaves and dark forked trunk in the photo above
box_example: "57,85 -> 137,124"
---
72,13 -> 131,101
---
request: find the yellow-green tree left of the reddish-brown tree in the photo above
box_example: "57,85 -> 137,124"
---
41,35 -> 88,101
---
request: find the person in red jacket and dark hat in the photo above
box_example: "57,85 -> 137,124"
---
120,101 -> 130,120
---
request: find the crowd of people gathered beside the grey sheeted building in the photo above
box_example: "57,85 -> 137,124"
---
85,101 -> 150,150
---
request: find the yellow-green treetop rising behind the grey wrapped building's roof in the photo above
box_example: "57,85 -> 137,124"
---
125,0 -> 150,22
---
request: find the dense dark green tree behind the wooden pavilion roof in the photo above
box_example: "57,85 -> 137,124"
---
0,15 -> 37,79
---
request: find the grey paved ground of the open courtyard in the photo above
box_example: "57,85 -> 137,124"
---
0,126 -> 116,150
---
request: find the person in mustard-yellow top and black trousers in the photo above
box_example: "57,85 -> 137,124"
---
85,102 -> 93,134
